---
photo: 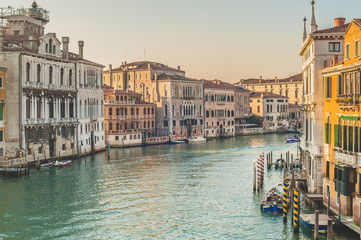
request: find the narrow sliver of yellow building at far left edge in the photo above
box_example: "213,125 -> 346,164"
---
0,67 -> 6,158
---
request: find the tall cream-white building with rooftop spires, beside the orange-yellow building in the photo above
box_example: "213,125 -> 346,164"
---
298,1 -> 348,193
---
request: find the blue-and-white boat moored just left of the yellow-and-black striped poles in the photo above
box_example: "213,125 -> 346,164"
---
261,184 -> 283,213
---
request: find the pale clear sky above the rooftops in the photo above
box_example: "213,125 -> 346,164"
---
0,0 -> 361,83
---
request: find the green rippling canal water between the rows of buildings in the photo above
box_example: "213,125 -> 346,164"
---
0,135 -> 358,240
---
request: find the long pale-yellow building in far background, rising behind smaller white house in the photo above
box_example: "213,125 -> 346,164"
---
234,73 -> 303,105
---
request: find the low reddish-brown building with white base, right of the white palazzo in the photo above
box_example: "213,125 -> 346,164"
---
104,85 -> 156,147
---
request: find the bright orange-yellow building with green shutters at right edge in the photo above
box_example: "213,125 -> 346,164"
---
322,19 -> 361,223
